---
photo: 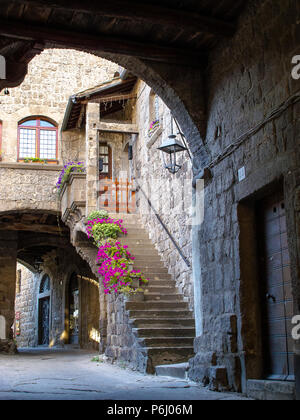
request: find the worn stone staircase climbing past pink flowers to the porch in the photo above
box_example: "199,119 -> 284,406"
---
116,215 -> 195,373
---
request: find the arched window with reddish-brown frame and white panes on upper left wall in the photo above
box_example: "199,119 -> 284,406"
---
18,118 -> 57,160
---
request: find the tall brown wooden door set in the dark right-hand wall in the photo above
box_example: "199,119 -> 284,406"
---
259,194 -> 294,380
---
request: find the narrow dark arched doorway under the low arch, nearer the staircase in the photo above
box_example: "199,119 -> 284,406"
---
68,273 -> 80,344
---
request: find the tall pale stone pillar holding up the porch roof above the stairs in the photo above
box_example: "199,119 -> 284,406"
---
86,104 -> 99,216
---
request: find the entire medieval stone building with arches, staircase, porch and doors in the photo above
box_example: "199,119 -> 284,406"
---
0,0 -> 300,399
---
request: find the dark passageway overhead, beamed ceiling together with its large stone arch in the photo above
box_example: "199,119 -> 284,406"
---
0,0 -> 243,170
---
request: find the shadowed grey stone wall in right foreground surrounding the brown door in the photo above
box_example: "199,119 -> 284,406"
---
190,0 -> 300,391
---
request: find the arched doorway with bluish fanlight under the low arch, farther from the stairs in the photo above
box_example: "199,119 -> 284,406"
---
38,274 -> 50,346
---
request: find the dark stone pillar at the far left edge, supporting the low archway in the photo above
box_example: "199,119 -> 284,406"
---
0,232 -> 17,338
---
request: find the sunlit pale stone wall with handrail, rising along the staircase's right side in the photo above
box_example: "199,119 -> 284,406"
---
132,81 -> 194,308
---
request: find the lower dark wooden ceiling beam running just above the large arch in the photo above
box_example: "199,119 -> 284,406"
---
0,20 -> 206,66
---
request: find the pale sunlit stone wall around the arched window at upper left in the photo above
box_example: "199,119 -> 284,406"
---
0,49 -> 118,162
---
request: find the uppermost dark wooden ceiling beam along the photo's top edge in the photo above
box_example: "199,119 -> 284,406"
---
18,0 -> 236,37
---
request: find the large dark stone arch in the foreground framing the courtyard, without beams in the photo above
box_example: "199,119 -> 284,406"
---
0,48 -> 209,173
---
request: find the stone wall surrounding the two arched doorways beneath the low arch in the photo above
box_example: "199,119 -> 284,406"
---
15,248 -> 100,350
